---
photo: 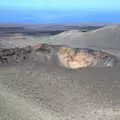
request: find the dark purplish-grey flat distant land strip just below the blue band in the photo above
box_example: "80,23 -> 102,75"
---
0,25 -> 103,36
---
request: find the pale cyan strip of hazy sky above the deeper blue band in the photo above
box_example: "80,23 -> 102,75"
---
0,0 -> 120,10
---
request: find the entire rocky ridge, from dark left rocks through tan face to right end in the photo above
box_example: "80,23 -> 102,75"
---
0,44 -> 116,69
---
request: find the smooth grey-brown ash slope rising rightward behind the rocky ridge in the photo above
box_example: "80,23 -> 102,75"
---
41,25 -> 120,58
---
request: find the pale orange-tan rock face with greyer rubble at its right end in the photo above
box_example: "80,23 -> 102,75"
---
57,47 -> 116,69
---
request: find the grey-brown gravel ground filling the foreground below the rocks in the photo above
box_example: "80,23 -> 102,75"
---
0,57 -> 120,120
